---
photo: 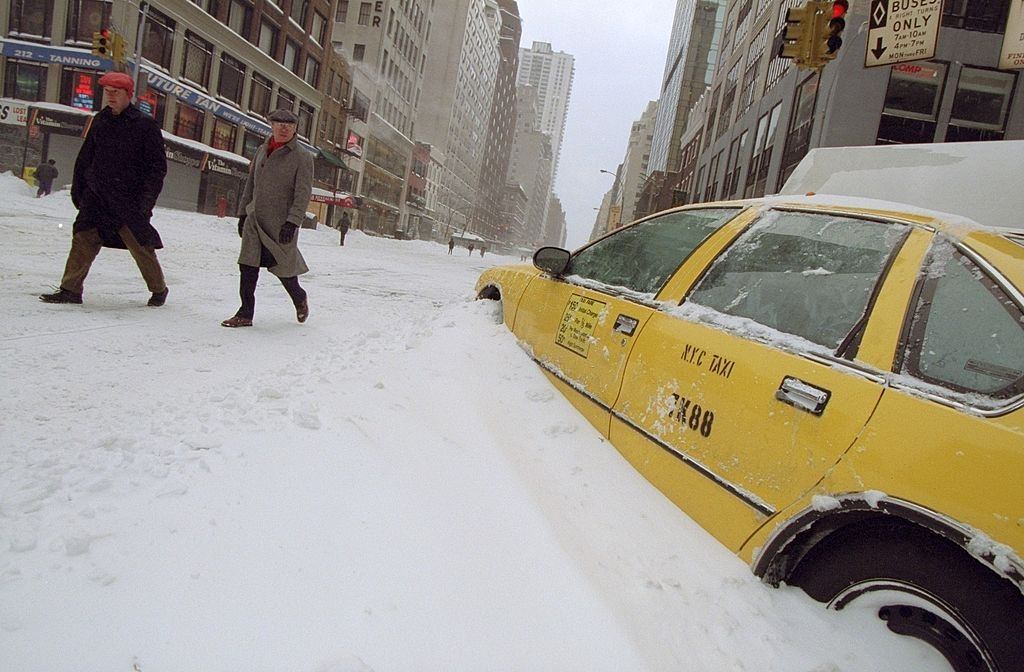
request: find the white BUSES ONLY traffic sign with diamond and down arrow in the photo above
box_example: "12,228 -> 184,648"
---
864,0 -> 937,68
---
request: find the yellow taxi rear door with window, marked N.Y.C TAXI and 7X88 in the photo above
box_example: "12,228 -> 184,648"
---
610,211 -> 925,550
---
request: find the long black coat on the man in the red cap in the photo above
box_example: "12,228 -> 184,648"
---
71,106 -> 167,249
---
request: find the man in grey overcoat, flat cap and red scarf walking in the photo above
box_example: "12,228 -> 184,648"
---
220,110 -> 313,327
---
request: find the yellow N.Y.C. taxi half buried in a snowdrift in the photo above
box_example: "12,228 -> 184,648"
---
476,197 -> 1024,672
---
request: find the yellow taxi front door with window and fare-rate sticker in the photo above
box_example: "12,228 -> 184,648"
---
513,207 -> 740,435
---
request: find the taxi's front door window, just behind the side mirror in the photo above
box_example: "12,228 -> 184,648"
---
566,208 -> 740,294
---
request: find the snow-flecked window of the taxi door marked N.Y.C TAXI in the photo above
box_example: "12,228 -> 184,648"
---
687,211 -> 907,349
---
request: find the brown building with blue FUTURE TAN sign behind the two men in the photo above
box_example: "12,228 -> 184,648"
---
0,0 -> 345,213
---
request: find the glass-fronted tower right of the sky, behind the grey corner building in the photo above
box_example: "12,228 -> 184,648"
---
647,0 -> 726,173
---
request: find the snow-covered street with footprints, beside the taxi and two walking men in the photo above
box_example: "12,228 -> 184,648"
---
0,174 -> 948,672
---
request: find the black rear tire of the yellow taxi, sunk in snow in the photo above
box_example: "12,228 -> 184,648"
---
786,519 -> 1024,672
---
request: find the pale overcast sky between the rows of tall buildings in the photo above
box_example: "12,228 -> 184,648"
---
517,0 -> 676,248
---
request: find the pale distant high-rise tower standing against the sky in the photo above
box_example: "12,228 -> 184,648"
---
516,42 -> 575,183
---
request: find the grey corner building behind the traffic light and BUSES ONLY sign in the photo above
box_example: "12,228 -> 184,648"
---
675,0 -> 1024,203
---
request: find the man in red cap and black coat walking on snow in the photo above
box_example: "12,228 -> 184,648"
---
39,72 -> 167,306
